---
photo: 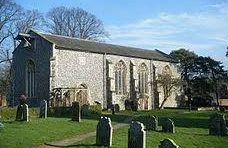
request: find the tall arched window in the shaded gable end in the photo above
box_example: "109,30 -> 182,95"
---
26,60 -> 35,97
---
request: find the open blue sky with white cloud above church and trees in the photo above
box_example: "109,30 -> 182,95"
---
16,0 -> 228,68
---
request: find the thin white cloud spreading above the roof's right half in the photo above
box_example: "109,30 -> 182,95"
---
107,4 -> 228,67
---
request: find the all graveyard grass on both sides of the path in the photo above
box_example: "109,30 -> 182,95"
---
0,109 -> 228,148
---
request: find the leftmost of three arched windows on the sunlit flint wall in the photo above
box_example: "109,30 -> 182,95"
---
115,61 -> 127,95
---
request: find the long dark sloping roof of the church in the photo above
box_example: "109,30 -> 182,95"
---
28,30 -> 176,61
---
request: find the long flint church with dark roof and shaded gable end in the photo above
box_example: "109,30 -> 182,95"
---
11,30 -> 180,110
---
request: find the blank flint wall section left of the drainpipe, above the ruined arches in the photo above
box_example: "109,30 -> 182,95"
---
51,49 -> 103,107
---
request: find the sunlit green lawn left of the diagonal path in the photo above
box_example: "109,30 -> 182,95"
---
0,118 -> 97,148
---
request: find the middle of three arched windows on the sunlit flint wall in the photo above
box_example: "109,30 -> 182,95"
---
138,63 -> 148,94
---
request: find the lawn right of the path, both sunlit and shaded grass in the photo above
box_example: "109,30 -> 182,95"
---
71,110 -> 228,148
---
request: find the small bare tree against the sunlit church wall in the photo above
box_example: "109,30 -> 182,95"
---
156,73 -> 181,109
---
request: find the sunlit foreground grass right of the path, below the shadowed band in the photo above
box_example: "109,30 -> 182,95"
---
71,127 -> 228,148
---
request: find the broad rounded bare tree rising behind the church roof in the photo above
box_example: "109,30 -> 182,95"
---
47,7 -> 108,40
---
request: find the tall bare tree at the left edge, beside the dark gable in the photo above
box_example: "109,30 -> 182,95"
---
0,0 -> 43,104
